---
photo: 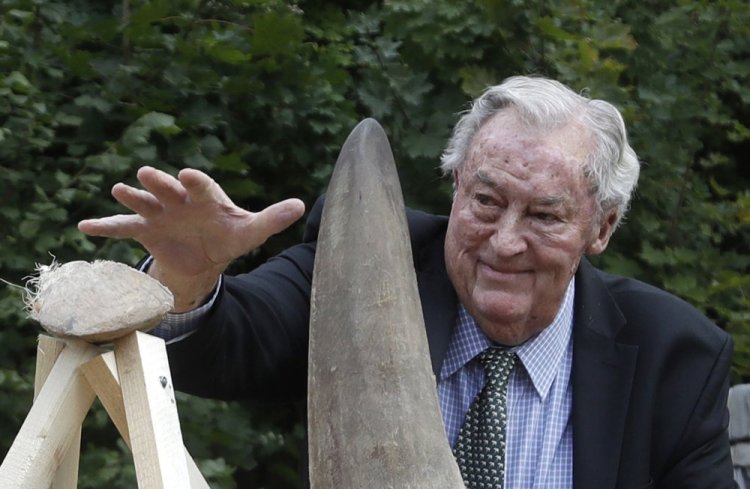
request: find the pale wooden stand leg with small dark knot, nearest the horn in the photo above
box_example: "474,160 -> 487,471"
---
115,332 -> 190,489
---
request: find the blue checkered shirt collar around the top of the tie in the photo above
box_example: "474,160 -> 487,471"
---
440,280 -> 575,399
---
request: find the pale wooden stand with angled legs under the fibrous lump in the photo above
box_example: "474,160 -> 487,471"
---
0,332 -> 209,489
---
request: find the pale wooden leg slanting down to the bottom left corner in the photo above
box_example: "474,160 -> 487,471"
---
0,341 -> 99,489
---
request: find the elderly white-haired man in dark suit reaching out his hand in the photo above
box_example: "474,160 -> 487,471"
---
80,77 -> 733,489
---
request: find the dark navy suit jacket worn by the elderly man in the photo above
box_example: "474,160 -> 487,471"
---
169,198 -> 734,489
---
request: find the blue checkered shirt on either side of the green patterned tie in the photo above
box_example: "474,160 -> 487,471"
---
438,281 -> 575,489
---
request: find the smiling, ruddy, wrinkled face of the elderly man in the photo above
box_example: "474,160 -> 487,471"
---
445,109 -> 615,345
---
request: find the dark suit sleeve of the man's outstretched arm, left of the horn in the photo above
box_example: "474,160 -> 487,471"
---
162,197 -> 322,401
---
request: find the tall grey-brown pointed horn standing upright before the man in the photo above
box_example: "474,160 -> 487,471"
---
308,119 -> 464,489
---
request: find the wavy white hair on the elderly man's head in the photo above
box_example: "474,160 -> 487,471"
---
441,76 -> 640,227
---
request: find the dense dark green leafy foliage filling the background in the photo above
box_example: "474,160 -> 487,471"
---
0,0 -> 750,488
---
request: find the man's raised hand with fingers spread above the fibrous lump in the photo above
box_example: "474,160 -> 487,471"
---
78,167 -> 305,311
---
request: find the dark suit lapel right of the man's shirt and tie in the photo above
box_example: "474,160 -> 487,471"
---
572,260 -> 638,489
